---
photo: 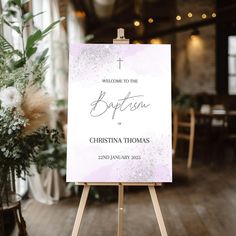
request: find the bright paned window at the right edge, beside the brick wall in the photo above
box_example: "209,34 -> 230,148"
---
228,36 -> 236,95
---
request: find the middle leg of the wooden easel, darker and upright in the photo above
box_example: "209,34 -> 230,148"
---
117,184 -> 124,236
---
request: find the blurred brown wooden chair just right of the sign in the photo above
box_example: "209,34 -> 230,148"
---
173,108 -> 195,168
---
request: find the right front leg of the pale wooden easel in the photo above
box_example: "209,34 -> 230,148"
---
148,186 -> 168,236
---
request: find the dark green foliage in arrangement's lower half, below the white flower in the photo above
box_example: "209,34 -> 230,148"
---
0,108 -> 58,177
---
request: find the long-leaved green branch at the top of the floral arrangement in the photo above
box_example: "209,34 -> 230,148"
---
0,0 -> 64,77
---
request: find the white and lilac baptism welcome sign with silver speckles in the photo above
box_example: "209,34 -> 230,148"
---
67,44 -> 172,183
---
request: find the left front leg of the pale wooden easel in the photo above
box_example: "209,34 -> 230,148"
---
72,185 -> 90,236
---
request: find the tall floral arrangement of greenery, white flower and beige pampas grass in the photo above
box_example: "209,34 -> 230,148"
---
0,0 -> 61,205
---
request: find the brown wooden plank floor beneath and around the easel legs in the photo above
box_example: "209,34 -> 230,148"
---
13,160 -> 236,236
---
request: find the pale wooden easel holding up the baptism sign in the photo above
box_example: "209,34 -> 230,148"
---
72,28 -> 168,236
